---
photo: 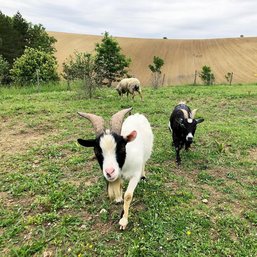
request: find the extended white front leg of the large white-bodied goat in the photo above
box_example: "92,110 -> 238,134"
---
119,175 -> 141,230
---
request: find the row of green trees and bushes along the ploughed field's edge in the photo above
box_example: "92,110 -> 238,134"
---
0,11 -> 226,93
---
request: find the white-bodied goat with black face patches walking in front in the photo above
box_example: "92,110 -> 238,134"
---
78,108 -> 153,230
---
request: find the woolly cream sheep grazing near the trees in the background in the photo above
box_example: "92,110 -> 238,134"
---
116,78 -> 143,100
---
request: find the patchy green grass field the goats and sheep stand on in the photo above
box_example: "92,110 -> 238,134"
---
0,85 -> 257,257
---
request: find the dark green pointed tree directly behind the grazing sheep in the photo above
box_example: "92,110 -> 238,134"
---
95,32 -> 131,87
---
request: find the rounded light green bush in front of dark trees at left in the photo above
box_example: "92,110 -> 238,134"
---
10,47 -> 58,85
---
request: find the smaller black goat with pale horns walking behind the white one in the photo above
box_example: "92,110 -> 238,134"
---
169,102 -> 204,164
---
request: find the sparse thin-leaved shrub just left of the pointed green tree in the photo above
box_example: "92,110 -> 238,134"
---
62,52 -> 97,98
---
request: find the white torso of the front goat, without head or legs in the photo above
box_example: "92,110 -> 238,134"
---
121,113 -> 153,179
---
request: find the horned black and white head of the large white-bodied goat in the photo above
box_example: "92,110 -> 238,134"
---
78,108 -> 137,182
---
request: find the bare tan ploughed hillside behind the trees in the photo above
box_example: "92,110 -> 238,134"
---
49,32 -> 257,85
